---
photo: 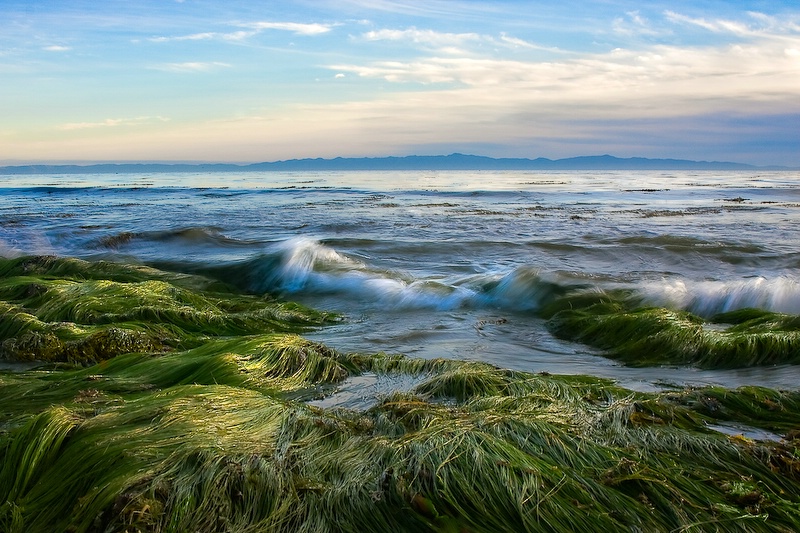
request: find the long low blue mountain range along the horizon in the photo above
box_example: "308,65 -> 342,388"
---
0,154 -> 792,174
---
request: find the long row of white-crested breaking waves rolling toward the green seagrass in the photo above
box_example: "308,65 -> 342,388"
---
208,237 -> 800,316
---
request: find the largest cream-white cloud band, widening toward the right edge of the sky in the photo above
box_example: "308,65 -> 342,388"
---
329,27 -> 800,115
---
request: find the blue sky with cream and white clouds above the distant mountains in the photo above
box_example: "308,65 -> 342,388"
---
0,0 -> 800,166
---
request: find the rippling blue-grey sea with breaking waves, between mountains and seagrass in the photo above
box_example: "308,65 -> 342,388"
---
0,171 -> 800,390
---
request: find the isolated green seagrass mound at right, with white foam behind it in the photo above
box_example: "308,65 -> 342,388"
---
543,293 -> 800,368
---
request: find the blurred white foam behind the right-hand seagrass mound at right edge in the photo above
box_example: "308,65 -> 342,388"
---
642,276 -> 800,316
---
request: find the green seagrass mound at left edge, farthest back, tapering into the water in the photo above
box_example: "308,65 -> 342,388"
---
0,257 -> 331,364
